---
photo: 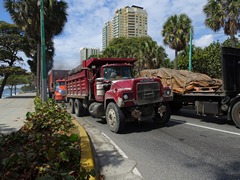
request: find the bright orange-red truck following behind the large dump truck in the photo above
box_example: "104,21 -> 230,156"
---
48,70 -> 69,102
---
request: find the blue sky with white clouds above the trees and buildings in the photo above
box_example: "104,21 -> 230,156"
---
0,0 -> 229,71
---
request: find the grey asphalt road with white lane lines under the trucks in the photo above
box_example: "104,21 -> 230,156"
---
72,106 -> 240,180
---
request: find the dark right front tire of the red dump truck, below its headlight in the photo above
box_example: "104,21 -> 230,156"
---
153,103 -> 171,125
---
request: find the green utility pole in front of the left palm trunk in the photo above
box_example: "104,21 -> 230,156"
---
38,0 -> 47,102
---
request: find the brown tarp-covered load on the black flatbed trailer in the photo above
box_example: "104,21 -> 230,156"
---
137,68 -> 222,94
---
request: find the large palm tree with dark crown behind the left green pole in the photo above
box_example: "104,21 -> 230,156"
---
4,0 -> 67,95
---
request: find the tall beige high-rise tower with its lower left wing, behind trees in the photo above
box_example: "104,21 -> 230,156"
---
102,5 -> 148,50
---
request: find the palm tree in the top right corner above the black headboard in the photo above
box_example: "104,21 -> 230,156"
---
203,0 -> 240,48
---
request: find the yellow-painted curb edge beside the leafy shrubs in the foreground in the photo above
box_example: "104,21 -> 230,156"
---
72,118 -> 97,180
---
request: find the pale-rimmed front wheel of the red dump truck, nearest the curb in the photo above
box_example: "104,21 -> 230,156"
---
106,102 -> 125,133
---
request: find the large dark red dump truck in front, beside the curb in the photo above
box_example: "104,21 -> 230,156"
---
66,58 -> 173,133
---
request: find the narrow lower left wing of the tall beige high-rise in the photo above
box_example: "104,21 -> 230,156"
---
102,21 -> 112,50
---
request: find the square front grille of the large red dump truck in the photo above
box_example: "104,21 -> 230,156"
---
137,82 -> 161,105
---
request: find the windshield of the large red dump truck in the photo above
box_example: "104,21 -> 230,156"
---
103,66 -> 133,80
